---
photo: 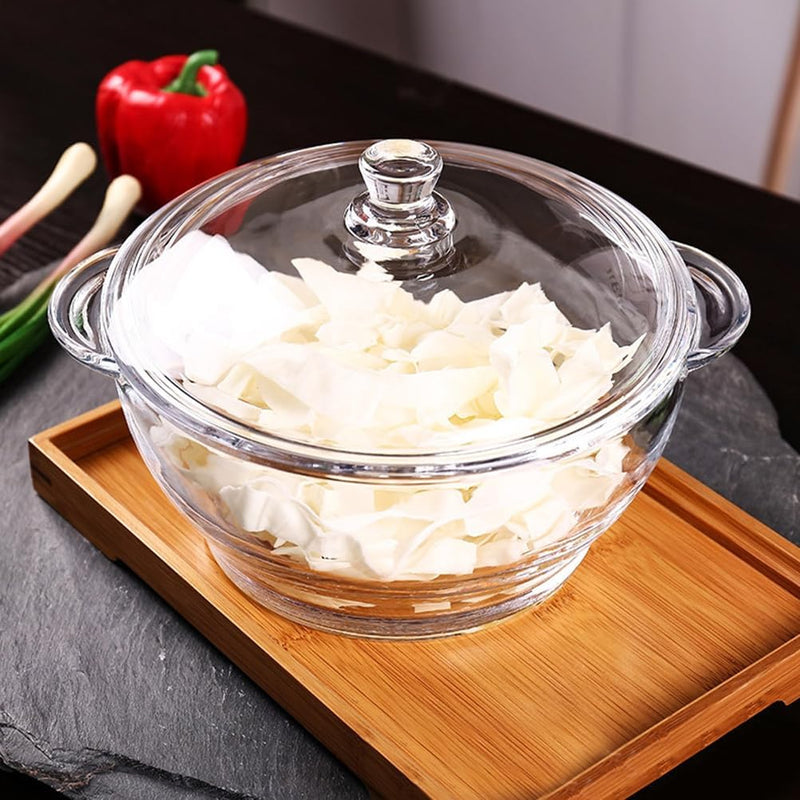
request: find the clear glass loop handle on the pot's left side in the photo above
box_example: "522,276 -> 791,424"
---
47,247 -> 119,378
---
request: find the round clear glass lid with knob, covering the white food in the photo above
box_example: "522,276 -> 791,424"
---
104,139 -> 697,471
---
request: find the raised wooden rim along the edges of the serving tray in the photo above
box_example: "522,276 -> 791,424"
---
29,400 -> 800,800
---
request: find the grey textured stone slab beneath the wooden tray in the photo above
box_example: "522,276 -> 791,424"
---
0,268 -> 800,800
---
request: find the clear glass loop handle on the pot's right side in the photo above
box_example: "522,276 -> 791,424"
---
672,242 -> 750,372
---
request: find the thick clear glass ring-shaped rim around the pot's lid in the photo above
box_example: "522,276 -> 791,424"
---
99,140 -> 699,481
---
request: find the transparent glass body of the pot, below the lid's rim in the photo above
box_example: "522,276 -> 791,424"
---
121,376 -> 681,638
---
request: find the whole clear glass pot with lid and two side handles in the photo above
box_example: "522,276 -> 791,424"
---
50,140 -> 749,638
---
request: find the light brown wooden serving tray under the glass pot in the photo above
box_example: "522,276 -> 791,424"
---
30,403 -> 800,800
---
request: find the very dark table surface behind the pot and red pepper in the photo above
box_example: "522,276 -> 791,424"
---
0,0 -> 800,797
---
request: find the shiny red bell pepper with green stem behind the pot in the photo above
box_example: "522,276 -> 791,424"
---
96,50 -> 247,211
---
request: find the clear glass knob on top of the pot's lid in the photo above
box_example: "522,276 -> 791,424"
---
344,139 -> 456,280
